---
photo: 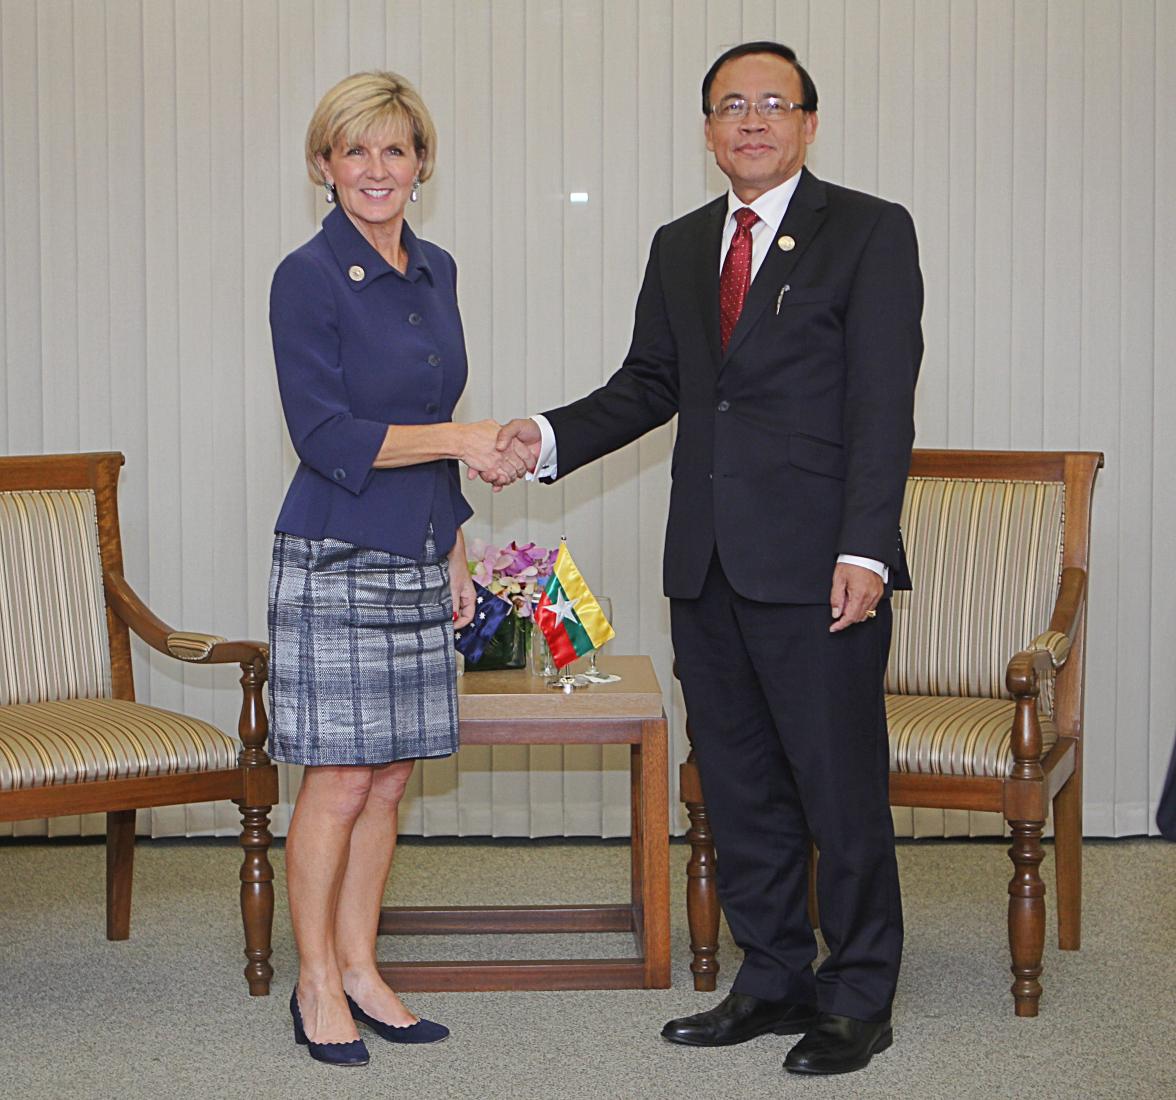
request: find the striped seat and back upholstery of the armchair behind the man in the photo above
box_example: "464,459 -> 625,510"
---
886,478 -> 1065,778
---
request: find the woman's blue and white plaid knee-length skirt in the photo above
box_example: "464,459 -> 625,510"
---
269,533 -> 457,765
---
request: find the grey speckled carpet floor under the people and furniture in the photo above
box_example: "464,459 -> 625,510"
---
0,840 -> 1176,1100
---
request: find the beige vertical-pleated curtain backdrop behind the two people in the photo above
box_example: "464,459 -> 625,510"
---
0,0 -> 1176,835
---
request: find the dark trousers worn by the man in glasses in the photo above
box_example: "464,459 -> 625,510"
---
670,554 -> 902,1020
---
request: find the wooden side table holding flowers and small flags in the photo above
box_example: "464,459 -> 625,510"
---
380,656 -> 669,992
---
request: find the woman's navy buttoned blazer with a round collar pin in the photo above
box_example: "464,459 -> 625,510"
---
269,207 -> 473,560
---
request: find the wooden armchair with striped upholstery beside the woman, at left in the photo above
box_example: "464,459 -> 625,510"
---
0,453 -> 278,995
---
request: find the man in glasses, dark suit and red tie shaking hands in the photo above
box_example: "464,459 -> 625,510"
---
499,42 -> 923,1073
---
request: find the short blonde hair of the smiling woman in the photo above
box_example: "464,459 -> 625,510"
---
306,73 -> 437,186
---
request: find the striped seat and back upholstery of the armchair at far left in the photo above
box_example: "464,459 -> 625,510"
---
0,489 -> 236,792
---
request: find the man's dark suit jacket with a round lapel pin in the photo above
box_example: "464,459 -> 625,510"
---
544,169 -> 923,604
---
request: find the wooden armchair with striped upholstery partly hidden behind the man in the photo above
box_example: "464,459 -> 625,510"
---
681,451 -> 1102,1016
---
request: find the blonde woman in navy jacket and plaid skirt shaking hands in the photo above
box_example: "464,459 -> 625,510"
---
269,73 -> 526,1065
